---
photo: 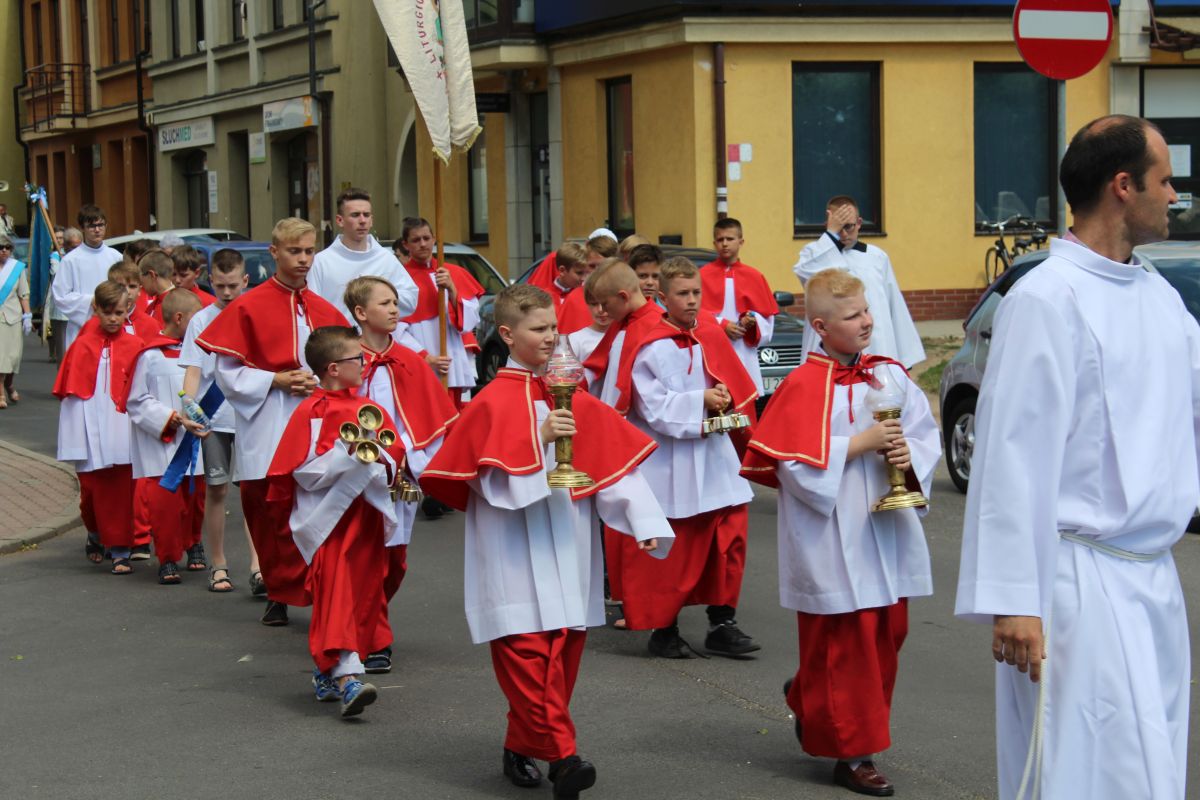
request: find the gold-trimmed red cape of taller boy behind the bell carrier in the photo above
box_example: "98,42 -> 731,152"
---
196,276 -> 349,372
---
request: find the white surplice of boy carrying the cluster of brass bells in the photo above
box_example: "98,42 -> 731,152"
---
285,419 -> 396,564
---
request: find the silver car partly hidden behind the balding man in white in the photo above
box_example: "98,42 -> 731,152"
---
940,241 -> 1200,492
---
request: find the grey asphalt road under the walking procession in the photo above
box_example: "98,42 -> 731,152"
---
0,351 -> 1200,800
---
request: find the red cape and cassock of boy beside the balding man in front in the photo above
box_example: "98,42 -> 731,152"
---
742,353 -> 919,759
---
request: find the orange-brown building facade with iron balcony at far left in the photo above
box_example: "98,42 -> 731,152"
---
17,0 -> 154,234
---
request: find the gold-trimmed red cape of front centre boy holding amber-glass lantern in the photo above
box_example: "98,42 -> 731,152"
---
421,367 -> 656,511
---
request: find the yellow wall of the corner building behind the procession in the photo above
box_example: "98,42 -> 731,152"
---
552,34 -> 1116,297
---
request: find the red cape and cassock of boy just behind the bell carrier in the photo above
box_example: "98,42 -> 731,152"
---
196,276 -> 347,606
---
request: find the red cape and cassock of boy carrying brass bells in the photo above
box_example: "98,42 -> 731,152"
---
268,389 -> 404,673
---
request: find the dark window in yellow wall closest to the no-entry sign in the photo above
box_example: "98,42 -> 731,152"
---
974,62 -> 1058,227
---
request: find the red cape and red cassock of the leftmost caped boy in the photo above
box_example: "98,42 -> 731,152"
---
54,317 -> 143,547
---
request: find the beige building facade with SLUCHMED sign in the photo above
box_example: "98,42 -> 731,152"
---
142,0 -> 419,240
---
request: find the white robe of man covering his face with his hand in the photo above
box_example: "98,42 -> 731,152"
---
792,233 -> 925,368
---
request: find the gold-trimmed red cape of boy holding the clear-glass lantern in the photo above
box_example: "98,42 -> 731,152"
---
740,353 -> 904,488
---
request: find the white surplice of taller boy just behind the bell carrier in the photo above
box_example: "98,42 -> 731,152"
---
216,307 -> 311,481
